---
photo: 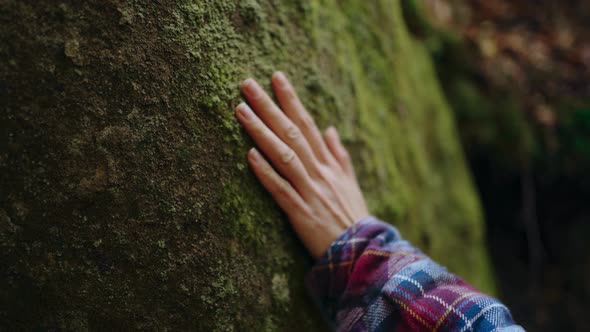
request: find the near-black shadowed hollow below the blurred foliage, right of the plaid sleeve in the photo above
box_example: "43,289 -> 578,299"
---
469,154 -> 590,331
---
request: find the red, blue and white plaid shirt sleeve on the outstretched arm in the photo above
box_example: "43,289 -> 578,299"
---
306,217 -> 524,331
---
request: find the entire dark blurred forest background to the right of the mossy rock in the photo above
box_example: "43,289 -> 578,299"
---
404,0 -> 590,331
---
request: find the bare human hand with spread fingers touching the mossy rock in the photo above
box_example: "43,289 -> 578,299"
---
236,72 -> 369,258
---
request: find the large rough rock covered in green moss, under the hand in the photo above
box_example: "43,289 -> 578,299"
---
0,0 -> 493,331
